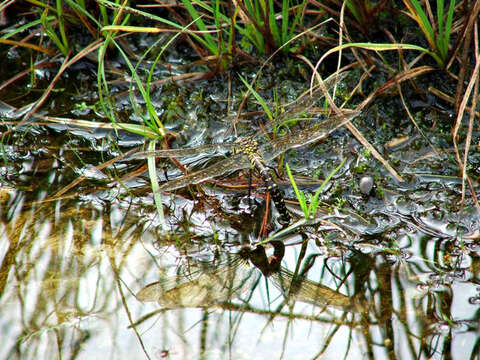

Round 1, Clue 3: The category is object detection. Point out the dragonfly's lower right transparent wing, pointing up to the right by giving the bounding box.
[262,111,360,161]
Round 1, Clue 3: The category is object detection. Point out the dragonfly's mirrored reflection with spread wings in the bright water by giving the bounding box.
[137,242,351,309]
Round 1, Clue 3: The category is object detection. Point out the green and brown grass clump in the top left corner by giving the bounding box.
[0,0,117,126]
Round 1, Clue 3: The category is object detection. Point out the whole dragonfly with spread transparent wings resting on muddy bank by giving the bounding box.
[131,72,359,223]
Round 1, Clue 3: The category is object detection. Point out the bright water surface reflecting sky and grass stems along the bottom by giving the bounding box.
[0,191,480,359]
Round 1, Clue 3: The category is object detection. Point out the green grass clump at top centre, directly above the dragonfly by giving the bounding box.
[99,0,307,72]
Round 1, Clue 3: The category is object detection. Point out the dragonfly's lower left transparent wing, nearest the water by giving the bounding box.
[159,154,250,192]
